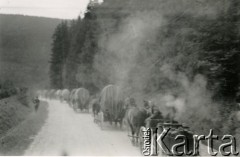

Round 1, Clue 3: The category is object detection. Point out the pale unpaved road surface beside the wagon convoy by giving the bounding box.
[25,101,141,156]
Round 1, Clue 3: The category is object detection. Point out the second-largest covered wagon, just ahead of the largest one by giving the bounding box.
[74,88,90,111]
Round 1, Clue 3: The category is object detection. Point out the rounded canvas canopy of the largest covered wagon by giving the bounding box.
[100,85,124,117]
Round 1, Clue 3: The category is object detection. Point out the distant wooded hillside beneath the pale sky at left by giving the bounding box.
[0,14,61,88]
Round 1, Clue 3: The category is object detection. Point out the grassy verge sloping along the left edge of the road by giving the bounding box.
[0,101,48,156]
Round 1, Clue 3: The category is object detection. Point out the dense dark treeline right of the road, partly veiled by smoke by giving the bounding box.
[50,0,240,133]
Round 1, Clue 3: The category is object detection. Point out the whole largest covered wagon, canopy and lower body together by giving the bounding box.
[100,85,125,124]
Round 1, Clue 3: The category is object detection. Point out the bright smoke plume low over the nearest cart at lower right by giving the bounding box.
[152,65,221,133]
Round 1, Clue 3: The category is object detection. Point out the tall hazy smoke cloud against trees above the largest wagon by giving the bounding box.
[95,12,164,92]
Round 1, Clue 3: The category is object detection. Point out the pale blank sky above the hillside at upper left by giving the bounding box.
[0,0,94,19]
